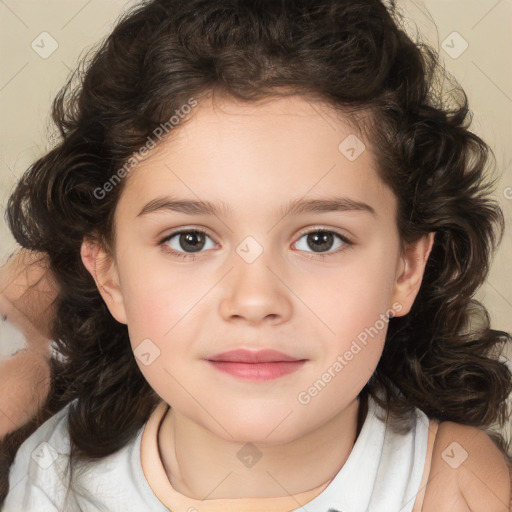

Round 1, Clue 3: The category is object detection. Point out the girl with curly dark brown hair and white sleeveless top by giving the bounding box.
[2,0,511,512]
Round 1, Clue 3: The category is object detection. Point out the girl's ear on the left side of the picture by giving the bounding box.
[80,238,127,324]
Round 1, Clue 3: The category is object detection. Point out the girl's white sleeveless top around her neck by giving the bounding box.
[2,397,429,512]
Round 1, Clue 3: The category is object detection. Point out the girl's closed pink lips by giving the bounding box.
[207,349,306,381]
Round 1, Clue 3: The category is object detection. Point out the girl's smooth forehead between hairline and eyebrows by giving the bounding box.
[119,96,394,220]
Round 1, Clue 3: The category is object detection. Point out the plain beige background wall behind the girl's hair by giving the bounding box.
[0,0,512,444]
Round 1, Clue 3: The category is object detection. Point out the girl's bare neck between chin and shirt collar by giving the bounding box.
[158,400,367,500]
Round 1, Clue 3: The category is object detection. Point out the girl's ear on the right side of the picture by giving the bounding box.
[392,232,435,316]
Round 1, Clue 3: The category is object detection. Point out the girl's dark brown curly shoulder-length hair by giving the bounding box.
[0,0,512,500]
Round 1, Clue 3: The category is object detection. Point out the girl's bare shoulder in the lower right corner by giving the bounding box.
[424,421,511,512]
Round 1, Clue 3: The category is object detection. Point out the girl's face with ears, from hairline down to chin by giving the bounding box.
[83,97,429,444]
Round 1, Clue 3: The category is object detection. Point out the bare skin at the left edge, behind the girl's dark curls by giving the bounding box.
[0,249,57,438]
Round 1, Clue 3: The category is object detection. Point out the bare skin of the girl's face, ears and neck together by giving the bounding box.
[82,96,433,499]
